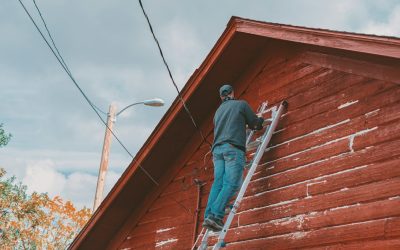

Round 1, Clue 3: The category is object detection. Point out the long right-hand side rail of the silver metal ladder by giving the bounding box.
[213,101,287,250]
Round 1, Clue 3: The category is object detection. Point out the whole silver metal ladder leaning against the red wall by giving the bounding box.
[192,101,288,250]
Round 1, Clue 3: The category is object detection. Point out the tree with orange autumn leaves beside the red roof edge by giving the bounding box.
[0,168,91,249]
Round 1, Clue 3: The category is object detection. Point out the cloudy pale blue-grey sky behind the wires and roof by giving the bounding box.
[0,0,400,208]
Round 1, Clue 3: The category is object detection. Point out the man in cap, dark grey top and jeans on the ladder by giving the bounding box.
[203,85,264,232]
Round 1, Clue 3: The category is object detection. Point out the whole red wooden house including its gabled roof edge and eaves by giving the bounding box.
[71,17,400,249]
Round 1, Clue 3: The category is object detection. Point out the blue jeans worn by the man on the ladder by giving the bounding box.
[204,143,245,219]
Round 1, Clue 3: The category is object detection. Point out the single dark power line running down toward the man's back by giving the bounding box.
[139,0,212,147]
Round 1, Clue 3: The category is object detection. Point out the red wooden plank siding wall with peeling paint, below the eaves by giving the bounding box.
[120,44,400,249]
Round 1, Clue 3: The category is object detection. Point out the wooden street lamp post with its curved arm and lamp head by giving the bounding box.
[93,98,164,212]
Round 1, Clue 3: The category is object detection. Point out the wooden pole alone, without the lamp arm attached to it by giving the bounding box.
[93,103,116,212]
